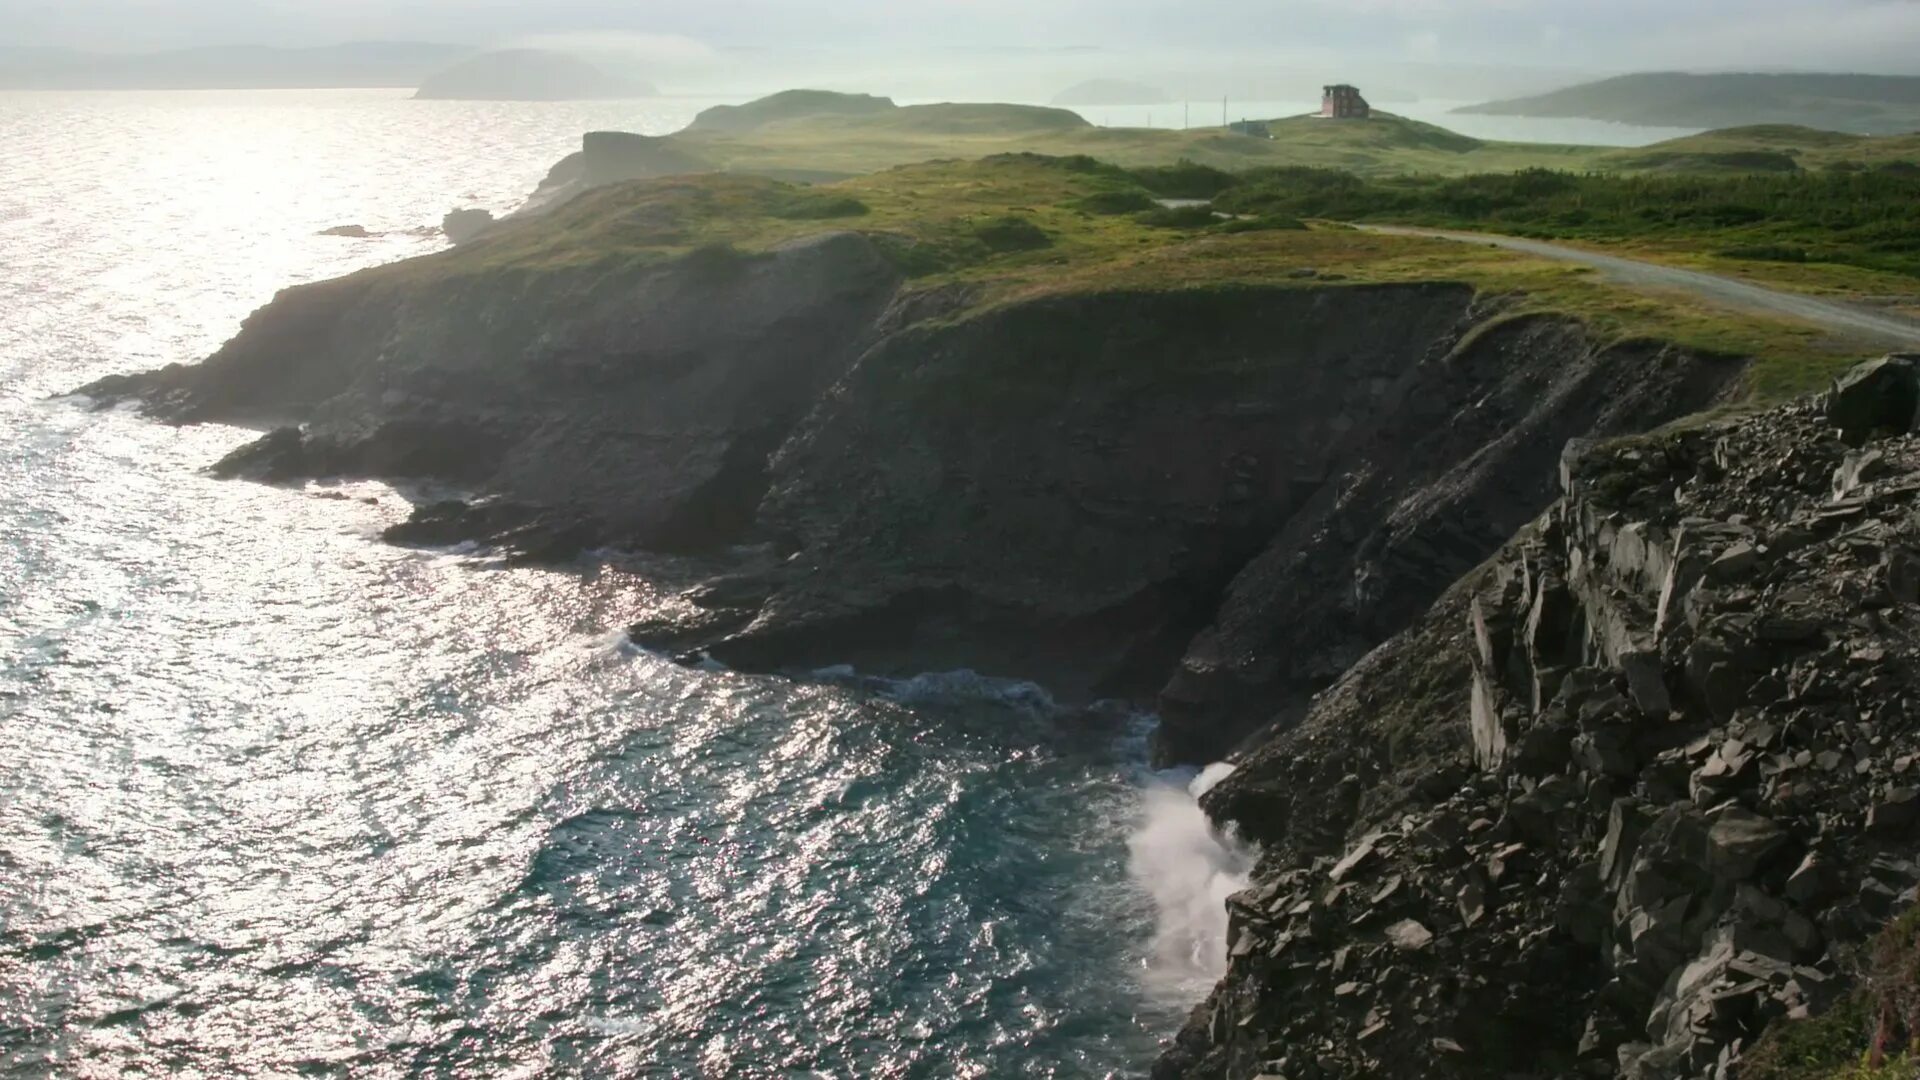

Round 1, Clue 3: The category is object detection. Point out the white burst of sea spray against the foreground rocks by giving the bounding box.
[1127,765,1254,986]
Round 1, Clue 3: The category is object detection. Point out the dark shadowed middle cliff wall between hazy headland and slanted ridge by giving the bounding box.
[668,286,1473,700]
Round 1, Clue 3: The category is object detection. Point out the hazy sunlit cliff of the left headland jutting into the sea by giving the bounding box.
[86,234,899,550]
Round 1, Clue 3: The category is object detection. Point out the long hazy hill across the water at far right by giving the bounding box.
[1455,73,1920,135]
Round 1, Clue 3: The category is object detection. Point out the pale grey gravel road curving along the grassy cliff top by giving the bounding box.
[1359,225,1920,348]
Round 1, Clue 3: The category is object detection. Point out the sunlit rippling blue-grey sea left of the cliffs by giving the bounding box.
[0,90,1248,1078]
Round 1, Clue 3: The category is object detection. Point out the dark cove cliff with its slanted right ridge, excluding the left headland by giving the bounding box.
[636,284,1738,703]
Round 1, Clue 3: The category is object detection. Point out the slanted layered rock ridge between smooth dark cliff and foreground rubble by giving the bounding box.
[1162,319,1738,761]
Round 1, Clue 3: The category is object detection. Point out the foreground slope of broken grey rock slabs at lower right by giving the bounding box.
[1158,359,1920,1078]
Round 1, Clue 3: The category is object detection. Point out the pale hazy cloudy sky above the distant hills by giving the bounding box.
[11,0,1920,73]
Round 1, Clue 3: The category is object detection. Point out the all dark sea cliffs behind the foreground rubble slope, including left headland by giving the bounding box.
[92,249,1738,714]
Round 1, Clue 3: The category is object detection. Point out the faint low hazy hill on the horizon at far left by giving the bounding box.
[0,42,472,90]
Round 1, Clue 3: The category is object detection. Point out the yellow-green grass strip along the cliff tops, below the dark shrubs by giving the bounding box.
[416,156,1876,400]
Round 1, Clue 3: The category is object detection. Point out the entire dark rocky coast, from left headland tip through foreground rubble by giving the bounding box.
[84,203,1920,1080]
